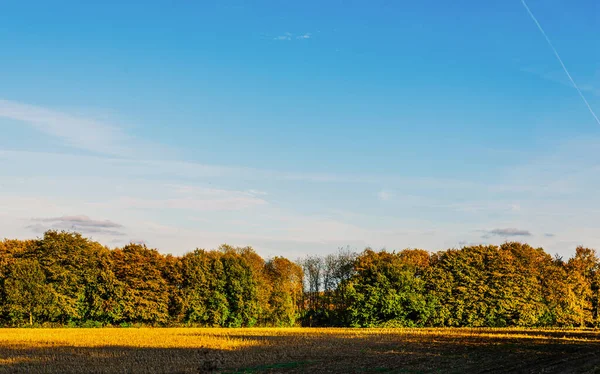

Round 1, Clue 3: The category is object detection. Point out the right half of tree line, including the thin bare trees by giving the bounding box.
[303,242,600,327]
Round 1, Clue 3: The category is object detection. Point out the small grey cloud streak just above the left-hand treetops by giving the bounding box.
[27,215,125,236]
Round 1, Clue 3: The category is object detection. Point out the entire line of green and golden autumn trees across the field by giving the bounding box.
[0,231,600,327]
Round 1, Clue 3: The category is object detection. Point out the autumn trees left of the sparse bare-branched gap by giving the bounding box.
[0,231,302,327]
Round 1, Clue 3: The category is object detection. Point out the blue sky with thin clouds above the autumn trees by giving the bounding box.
[0,0,600,259]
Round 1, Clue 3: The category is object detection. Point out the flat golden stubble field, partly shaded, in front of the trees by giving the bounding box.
[0,328,600,373]
